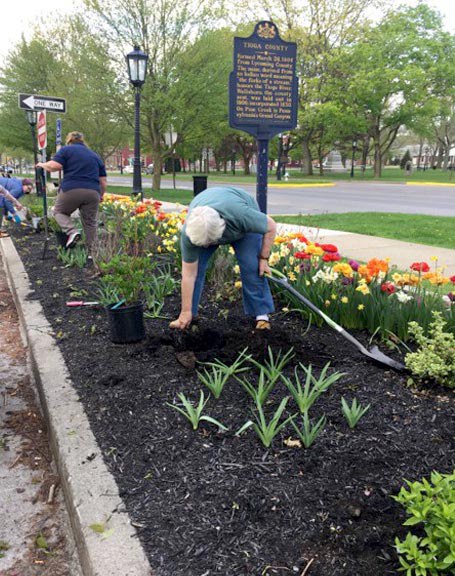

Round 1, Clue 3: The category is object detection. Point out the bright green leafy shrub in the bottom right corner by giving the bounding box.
[393,472,455,576]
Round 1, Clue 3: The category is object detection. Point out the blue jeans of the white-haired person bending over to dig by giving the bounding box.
[192,233,275,316]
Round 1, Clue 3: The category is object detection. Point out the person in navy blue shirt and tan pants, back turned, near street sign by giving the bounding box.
[36,132,107,252]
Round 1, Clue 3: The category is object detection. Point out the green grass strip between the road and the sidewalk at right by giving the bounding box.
[274,212,455,249]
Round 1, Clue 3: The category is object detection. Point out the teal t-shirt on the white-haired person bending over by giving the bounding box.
[180,186,267,262]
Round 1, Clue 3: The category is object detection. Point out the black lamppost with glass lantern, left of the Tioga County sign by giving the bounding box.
[126,46,148,200]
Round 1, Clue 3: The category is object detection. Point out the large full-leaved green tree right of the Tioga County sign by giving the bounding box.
[346,4,448,177]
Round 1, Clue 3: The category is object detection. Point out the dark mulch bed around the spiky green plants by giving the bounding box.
[9,230,455,576]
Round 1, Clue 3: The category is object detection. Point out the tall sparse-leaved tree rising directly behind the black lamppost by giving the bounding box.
[84,0,224,190]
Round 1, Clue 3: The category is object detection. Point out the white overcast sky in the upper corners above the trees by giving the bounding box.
[0,0,455,62]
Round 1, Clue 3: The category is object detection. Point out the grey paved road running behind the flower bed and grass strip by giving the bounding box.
[109,176,455,216]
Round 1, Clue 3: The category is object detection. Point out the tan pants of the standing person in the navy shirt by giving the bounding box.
[54,188,100,250]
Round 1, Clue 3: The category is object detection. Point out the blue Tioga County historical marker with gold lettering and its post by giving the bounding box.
[229,21,298,213]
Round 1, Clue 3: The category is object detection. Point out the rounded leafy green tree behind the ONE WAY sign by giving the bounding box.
[0,17,125,157]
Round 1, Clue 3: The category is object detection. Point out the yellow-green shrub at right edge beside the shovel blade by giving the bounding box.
[405,312,455,388]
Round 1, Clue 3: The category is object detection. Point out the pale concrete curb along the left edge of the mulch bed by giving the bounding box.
[0,238,152,576]
